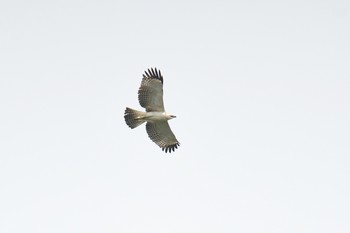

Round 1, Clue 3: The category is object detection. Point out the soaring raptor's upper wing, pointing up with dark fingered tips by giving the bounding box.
[138,68,165,112]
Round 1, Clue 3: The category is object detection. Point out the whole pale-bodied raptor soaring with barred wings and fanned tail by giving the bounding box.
[124,68,180,153]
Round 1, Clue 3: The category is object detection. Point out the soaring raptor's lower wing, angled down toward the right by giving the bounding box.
[146,121,180,153]
